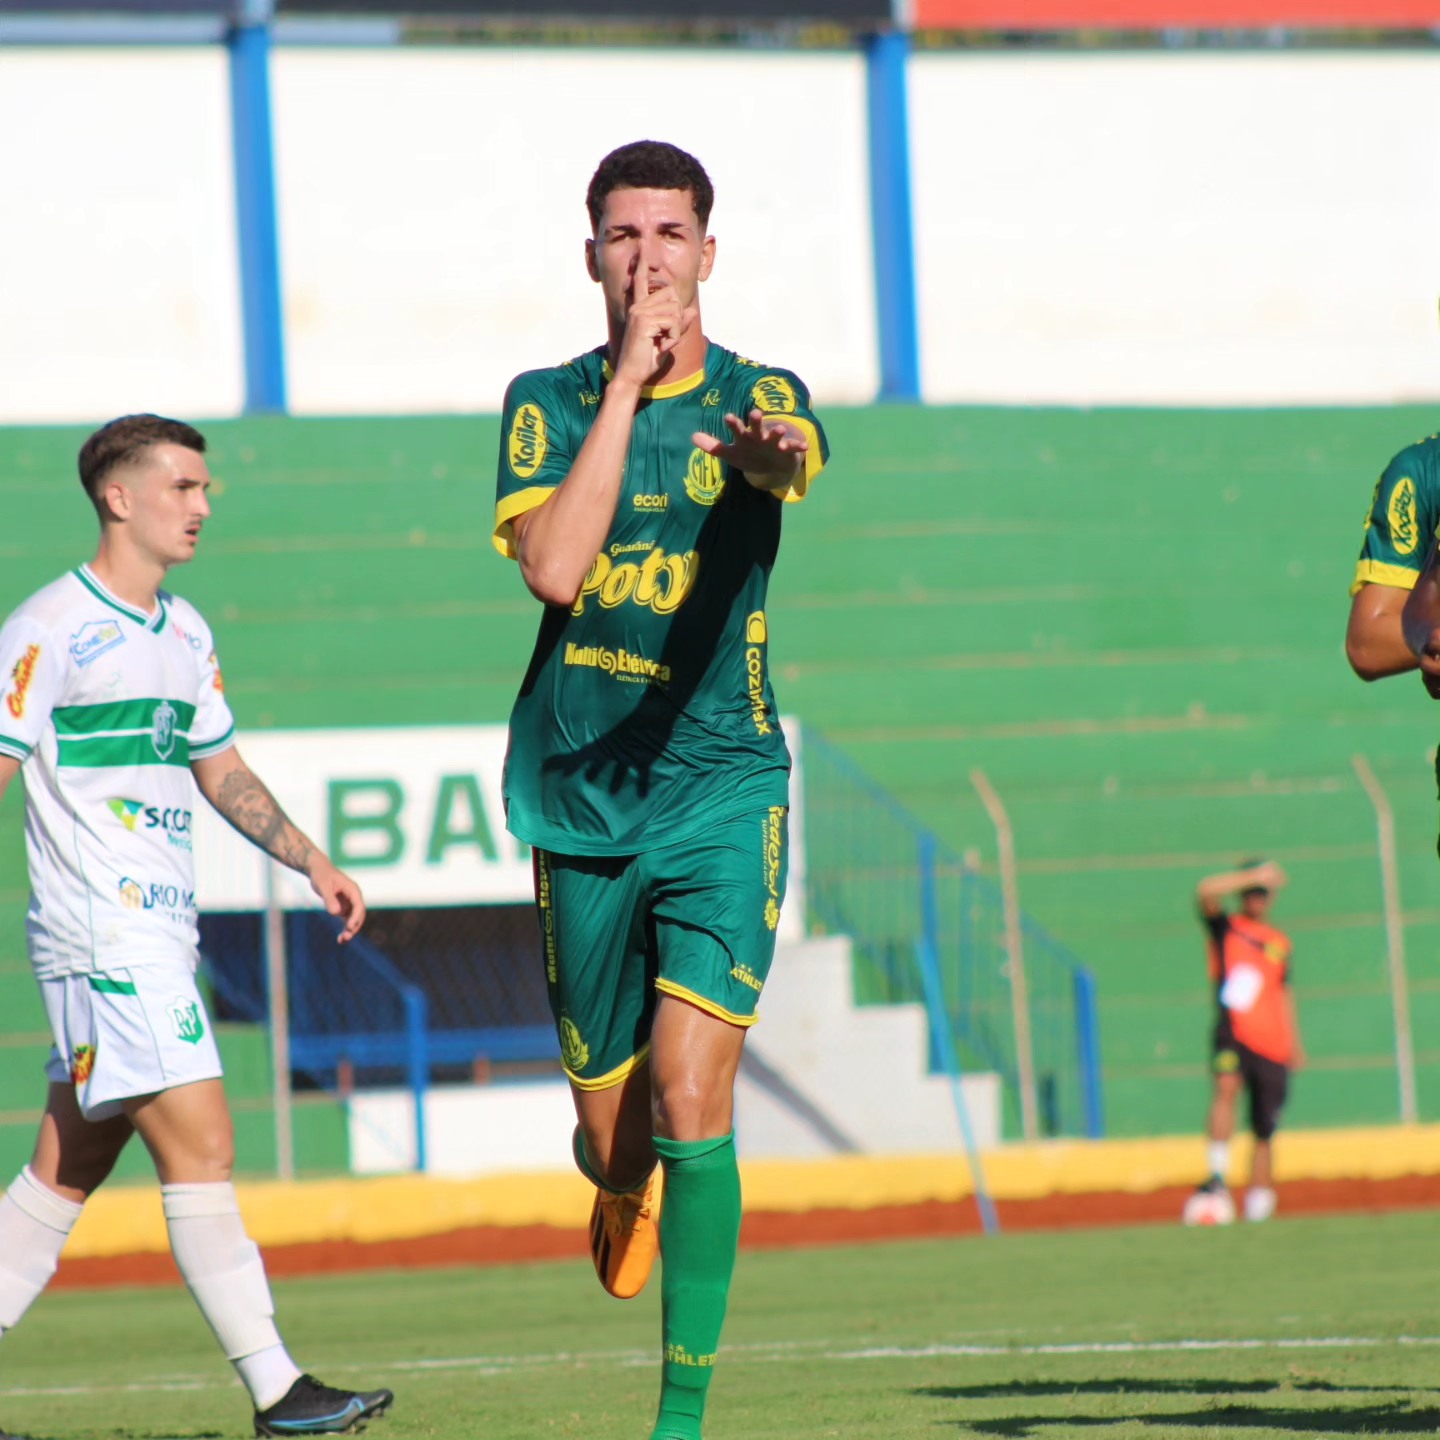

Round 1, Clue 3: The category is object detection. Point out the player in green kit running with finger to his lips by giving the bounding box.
[495,141,827,1440]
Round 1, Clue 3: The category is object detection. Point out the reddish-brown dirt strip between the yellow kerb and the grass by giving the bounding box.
[45,1175,1440,1287]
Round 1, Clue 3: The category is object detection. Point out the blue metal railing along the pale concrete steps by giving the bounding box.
[802,729,1104,1136]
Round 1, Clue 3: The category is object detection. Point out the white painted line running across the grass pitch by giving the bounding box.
[0,1335,1440,1400]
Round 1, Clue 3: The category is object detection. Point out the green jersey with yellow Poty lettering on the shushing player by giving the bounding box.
[494,344,828,855]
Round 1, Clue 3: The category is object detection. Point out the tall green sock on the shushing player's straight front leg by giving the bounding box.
[651,1133,740,1440]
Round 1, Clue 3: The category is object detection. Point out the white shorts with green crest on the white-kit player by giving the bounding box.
[40,960,220,1120]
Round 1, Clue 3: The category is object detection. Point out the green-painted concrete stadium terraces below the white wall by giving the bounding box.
[0,406,1440,1135]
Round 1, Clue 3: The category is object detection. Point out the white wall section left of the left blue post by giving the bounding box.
[0,46,243,422]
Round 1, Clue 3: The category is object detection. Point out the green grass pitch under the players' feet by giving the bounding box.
[0,1214,1440,1440]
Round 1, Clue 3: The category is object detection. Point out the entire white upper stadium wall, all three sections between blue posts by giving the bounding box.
[0,48,1440,423]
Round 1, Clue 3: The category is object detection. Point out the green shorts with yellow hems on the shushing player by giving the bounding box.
[534,805,789,1090]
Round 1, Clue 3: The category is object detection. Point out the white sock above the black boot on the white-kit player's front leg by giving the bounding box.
[160,1182,300,1410]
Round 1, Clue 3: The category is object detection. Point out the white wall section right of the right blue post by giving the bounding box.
[910,52,1440,405]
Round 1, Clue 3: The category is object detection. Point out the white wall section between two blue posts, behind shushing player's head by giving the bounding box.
[274,49,878,413]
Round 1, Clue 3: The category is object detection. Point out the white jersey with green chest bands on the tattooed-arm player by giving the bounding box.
[0,566,235,979]
